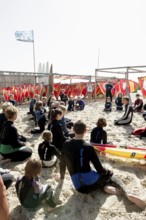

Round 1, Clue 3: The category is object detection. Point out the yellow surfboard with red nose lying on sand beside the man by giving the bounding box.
[94,146,146,159]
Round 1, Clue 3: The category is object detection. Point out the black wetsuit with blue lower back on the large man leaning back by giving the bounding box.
[62,139,112,193]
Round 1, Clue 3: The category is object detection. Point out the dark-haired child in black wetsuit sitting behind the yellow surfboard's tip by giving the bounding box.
[90,118,107,144]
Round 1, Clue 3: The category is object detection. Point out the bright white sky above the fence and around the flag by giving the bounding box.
[0,0,146,81]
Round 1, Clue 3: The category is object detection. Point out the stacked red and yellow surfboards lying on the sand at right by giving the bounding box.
[91,143,146,159]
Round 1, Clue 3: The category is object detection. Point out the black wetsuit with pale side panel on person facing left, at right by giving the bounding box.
[114,104,133,125]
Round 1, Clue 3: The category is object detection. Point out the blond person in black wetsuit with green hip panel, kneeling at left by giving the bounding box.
[0,106,32,161]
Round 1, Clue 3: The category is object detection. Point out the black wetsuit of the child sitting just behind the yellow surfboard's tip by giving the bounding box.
[90,127,107,144]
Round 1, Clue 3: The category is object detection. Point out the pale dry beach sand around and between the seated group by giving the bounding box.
[3,93,146,220]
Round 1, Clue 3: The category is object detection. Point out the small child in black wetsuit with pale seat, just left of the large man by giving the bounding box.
[38,130,60,167]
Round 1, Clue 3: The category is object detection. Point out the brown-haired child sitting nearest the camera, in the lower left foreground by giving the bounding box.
[15,159,55,209]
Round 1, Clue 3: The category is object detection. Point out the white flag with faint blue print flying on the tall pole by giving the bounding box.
[15,31,34,42]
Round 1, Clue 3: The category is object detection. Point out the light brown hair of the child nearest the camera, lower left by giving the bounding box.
[25,158,42,179]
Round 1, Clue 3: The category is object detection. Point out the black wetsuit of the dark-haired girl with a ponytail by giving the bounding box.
[48,120,66,151]
